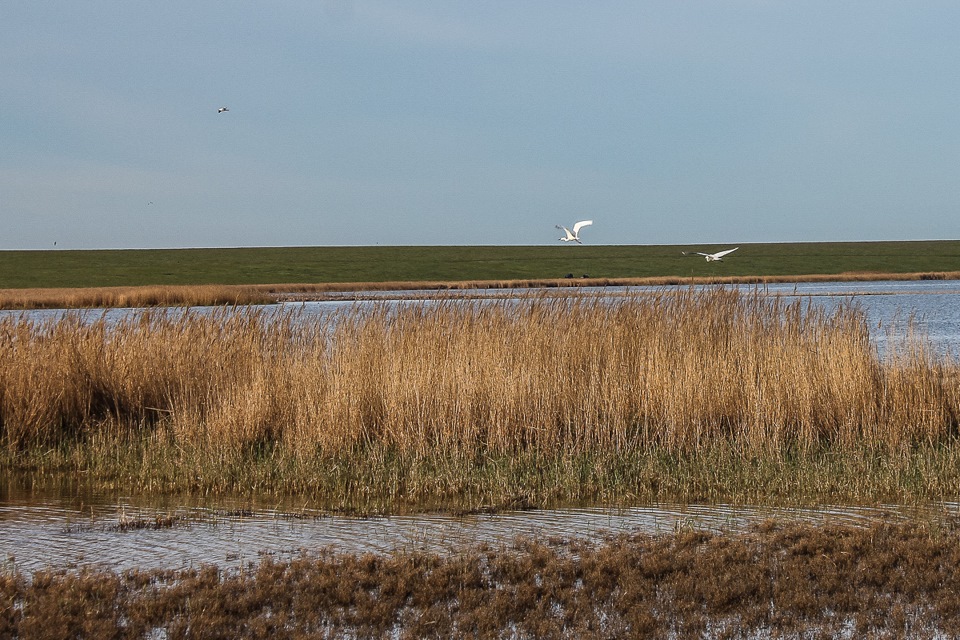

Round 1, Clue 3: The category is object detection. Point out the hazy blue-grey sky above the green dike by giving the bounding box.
[0,0,960,250]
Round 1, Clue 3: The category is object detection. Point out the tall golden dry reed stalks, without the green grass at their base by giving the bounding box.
[0,289,960,457]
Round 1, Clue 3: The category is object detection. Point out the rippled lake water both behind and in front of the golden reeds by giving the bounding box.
[0,281,960,573]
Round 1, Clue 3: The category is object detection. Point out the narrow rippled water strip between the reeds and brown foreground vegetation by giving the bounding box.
[0,488,960,574]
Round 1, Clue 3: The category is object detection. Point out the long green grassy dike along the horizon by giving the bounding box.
[0,240,960,289]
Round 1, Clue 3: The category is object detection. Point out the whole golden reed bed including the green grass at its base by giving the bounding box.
[0,289,960,510]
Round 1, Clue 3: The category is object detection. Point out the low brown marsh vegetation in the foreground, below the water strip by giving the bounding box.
[0,523,960,639]
